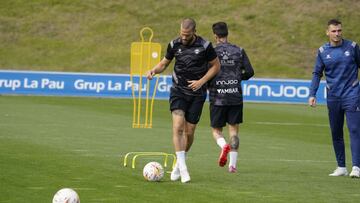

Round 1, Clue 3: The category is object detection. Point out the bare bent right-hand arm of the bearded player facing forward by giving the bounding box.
[188,57,220,91]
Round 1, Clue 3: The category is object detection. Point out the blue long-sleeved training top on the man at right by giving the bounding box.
[310,39,360,100]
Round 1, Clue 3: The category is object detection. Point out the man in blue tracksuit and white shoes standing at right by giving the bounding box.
[309,19,360,178]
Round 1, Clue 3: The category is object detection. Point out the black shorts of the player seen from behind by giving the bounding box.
[210,104,243,128]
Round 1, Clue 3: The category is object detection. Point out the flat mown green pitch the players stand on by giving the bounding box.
[0,96,360,203]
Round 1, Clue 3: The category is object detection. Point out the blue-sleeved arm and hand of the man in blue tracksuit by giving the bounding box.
[308,51,325,107]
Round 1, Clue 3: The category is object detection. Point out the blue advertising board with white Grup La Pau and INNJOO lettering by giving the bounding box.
[0,70,326,104]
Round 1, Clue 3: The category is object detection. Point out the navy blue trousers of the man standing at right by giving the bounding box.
[327,96,360,167]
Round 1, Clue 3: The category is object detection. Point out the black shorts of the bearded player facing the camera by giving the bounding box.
[169,88,206,124]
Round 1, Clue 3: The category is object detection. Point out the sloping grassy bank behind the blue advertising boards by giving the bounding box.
[0,0,360,79]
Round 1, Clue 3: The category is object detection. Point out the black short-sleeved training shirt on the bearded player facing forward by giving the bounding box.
[165,36,217,96]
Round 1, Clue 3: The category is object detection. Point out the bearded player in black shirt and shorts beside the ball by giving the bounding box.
[147,18,220,183]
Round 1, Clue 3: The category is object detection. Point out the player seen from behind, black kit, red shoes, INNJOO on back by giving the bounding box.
[209,22,254,173]
